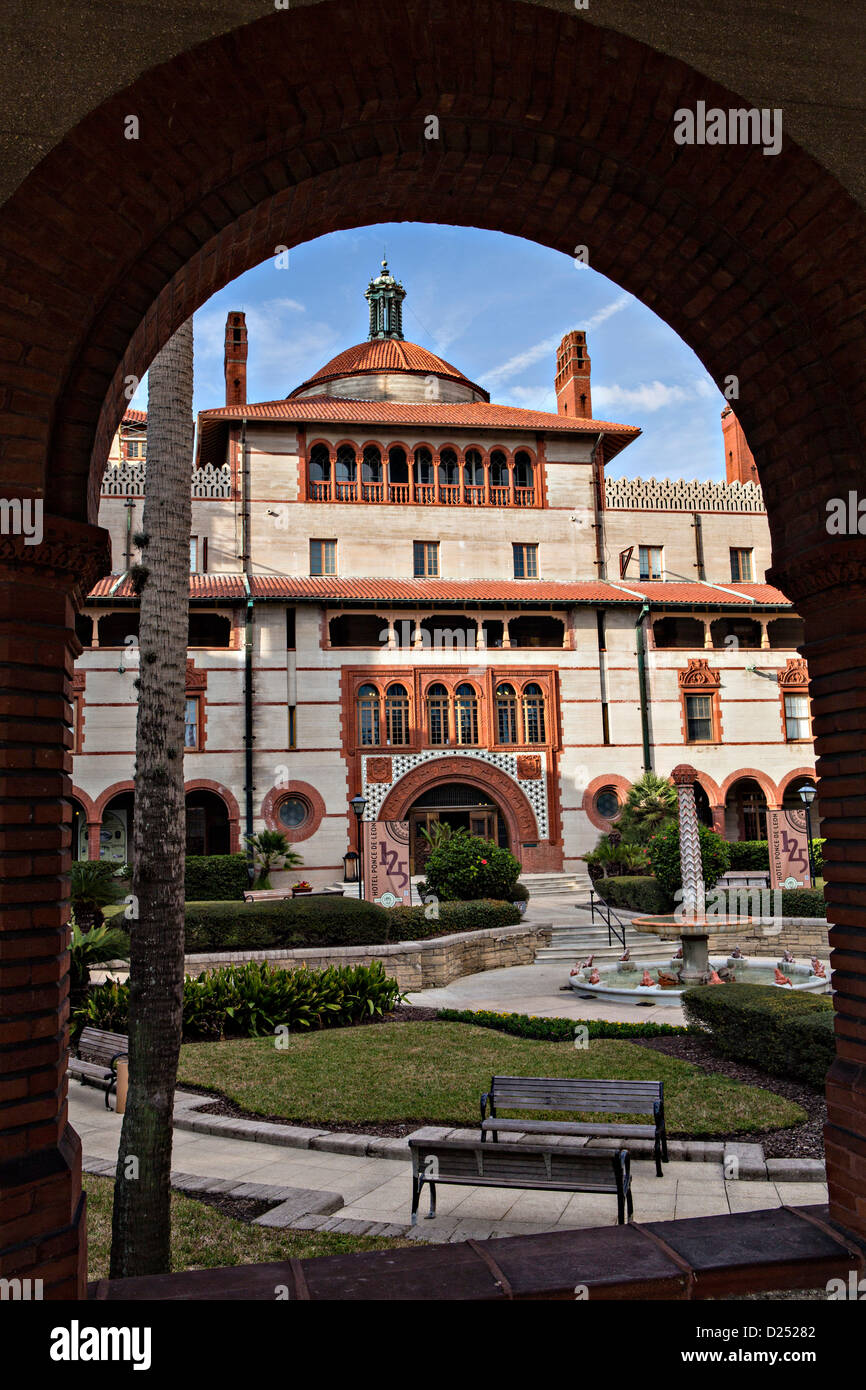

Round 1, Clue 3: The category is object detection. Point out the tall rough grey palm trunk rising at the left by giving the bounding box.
[111,320,193,1279]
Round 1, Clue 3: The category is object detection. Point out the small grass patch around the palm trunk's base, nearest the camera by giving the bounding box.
[83,1170,409,1279]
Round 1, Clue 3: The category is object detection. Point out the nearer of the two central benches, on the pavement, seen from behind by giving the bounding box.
[409,1138,634,1226]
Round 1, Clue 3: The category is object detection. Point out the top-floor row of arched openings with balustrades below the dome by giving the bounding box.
[307,443,538,507]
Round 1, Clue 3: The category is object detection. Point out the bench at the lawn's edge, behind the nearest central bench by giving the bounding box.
[481,1076,667,1177]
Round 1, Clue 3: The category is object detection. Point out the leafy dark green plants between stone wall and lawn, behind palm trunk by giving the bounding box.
[75,960,402,1041]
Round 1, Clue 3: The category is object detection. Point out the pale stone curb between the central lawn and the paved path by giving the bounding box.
[174,1091,827,1183]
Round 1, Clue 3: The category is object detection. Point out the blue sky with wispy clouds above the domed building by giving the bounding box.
[132,222,726,478]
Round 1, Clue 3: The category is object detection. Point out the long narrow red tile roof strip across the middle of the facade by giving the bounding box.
[89,574,791,609]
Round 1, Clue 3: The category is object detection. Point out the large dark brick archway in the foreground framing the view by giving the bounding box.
[0,0,866,1297]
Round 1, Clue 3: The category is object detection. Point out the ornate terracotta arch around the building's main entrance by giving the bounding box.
[377,758,562,873]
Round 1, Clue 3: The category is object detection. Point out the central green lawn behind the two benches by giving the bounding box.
[178,1022,806,1136]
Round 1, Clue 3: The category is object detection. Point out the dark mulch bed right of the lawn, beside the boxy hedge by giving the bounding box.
[628,1034,827,1159]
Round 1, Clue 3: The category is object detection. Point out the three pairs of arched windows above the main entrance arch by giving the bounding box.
[356,681,546,748]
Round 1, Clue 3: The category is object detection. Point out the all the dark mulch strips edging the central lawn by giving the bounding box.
[182,1005,827,1159]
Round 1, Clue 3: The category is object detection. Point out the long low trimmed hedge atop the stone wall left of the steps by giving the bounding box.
[186,894,523,954]
